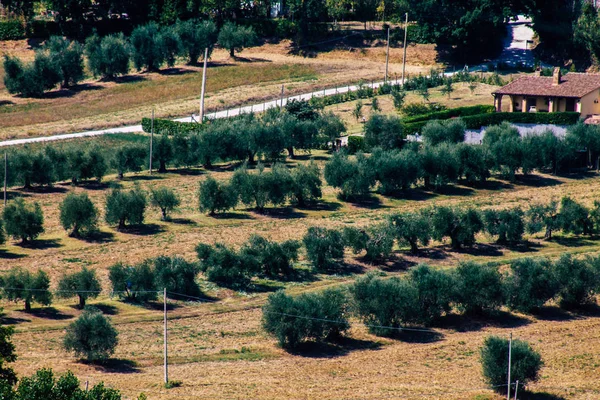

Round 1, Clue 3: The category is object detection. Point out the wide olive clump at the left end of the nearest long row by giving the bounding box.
[262,289,350,349]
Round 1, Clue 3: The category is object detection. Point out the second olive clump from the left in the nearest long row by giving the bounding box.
[350,274,418,336]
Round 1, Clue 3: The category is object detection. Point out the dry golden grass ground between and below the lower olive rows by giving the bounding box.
[0,145,600,400]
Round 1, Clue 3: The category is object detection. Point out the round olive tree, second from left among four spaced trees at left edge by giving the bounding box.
[59,193,98,237]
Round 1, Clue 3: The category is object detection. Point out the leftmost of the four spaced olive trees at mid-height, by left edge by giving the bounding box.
[2,197,44,244]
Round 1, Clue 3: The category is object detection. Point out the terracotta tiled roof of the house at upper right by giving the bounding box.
[494,72,600,98]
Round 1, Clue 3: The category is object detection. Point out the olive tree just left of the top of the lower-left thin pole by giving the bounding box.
[108,260,157,302]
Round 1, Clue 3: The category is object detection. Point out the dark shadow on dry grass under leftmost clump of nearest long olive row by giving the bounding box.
[289,336,381,358]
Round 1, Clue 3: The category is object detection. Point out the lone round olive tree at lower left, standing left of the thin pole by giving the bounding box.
[63,308,118,361]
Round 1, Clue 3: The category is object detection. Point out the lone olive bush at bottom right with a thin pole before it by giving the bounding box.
[481,336,543,393]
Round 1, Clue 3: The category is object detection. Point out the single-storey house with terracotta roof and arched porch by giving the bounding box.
[492,68,600,117]
